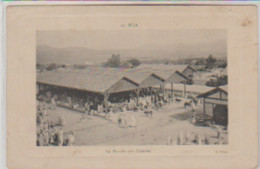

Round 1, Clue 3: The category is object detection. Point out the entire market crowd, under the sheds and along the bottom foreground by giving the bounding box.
[37,84,211,146]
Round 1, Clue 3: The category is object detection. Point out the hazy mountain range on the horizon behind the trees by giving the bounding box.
[36,45,226,65]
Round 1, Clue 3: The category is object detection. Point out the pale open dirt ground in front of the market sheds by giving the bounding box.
[38,103,228,146]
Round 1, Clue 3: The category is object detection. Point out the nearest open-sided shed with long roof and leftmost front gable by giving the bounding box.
[37,69,138,111]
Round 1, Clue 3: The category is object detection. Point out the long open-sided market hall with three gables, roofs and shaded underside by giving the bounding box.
[37,67,193,112]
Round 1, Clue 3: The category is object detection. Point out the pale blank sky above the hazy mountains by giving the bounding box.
[36,29,227,64]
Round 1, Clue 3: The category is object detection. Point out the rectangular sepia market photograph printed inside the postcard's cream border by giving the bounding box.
[36,29,229,146]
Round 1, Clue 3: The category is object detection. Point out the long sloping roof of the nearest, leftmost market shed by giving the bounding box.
[37,68,137,93]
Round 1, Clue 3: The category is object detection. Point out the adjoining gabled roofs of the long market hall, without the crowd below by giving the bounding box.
[37,67,193,93]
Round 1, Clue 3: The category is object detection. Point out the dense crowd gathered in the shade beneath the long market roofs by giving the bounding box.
[37,85,185,114]
